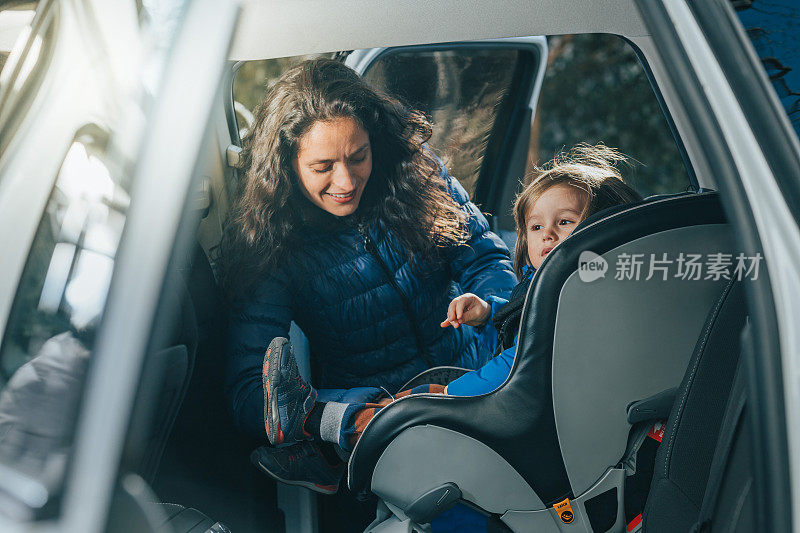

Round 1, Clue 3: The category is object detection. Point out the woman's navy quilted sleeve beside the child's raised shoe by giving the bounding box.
[225,268,292,440]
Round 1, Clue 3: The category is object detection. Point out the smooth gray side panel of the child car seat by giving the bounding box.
[552,224,733,495]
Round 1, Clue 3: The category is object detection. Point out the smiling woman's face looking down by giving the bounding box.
[293,118,372,217]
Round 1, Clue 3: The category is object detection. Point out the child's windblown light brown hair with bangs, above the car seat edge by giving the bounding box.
[514,143,642,279]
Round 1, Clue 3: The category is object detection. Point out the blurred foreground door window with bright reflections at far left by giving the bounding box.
[0,127,129,512]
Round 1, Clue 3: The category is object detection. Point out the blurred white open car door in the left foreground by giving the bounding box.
[0,0,237,531]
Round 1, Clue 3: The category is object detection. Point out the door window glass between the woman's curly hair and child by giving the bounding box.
[364,48,521,196]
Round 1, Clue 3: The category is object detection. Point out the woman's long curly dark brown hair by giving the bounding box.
[215,58,468,300]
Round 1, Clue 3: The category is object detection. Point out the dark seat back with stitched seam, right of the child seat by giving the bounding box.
[643,276,746,532]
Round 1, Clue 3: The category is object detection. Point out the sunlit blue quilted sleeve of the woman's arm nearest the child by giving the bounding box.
[442,167,517,300]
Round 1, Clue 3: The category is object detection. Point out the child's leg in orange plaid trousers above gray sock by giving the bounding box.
[305,385,444,451]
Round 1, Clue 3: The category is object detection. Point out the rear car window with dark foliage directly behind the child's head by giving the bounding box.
[528,34,690,196]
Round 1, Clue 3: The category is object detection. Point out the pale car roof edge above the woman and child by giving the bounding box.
[230,0,647,60]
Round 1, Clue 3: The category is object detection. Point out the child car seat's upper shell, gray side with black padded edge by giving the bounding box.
[348,193,733,528]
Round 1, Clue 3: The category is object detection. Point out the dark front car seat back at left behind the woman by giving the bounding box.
[153,245,282,531]
